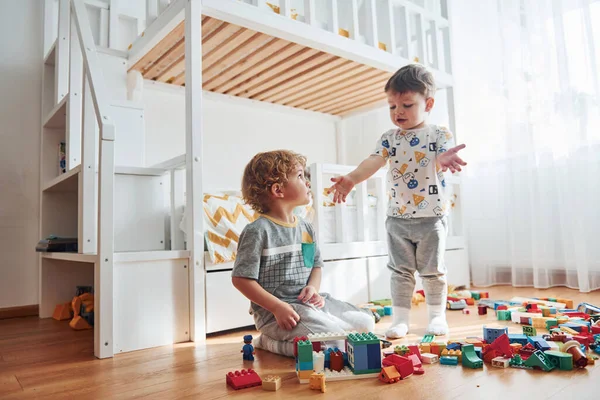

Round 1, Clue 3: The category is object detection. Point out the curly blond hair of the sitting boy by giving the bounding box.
[242,150,306,213]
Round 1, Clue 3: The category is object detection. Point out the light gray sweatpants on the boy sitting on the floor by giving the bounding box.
[255,293,375,356]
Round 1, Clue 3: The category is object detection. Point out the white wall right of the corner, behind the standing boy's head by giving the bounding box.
[339,89,450,165]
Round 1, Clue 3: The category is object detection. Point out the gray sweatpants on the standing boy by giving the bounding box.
[385,217,448,308]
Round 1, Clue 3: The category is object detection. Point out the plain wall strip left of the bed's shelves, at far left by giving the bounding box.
[0,0,43,308]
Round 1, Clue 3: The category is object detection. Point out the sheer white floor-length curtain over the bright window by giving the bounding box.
[450,0,600,292]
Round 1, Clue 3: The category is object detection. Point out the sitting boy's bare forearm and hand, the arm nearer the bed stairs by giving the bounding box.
[231,276,300,331]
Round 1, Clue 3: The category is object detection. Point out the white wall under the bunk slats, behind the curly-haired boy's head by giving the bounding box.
[144,81,337,190]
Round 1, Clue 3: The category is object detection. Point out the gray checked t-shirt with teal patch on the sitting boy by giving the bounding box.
[231,216,323,324]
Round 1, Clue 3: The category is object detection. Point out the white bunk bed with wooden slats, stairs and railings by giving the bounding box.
[40,0,468,358]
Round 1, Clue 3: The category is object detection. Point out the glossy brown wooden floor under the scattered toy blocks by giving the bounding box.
[0,287,600,400]
